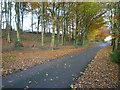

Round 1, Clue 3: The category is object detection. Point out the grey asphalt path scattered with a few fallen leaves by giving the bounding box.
[2,43,108,88]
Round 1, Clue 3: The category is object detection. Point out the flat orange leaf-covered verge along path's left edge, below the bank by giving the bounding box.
[2,45,95,76]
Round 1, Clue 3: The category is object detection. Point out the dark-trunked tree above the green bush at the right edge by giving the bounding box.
[111,2,120,51]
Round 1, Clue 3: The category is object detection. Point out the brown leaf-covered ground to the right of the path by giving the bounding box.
[71,46,120,88]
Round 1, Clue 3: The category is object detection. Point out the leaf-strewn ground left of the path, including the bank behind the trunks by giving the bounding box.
[0,30,98,76]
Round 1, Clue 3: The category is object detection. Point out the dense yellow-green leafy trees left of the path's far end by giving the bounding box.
[68,2,105,46]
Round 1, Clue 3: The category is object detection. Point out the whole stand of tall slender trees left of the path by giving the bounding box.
[1,2,111,50]
